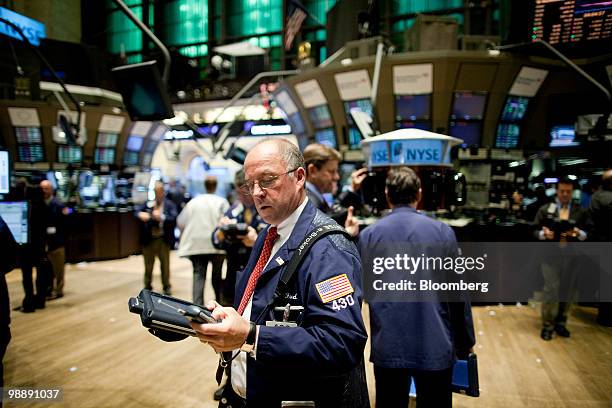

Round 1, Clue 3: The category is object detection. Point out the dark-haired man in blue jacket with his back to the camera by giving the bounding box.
[359,167,474,408]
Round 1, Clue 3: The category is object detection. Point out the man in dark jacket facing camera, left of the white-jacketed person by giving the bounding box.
[137,181,177,295]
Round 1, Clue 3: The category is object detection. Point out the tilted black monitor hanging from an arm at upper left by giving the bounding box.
[111,61,174,121]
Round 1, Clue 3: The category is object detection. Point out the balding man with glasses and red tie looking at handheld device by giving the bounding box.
[192,140,369,408]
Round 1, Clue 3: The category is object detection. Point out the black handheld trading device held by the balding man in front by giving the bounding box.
[128,289,218,336]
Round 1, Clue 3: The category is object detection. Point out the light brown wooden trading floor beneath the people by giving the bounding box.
[5,254,612,408]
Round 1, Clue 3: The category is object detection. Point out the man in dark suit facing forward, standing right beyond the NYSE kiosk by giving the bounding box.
[533,178,589,341]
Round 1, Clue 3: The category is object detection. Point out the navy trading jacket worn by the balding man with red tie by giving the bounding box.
[234,202,367,407]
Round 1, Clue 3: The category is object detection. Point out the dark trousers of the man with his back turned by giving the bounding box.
[374,365,453,408]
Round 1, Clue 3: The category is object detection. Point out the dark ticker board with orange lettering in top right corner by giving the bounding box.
[529,0,612,44]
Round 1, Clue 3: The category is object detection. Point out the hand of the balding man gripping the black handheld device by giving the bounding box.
[191,301,250,353]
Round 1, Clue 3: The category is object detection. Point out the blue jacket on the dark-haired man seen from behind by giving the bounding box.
[359,207,475,370]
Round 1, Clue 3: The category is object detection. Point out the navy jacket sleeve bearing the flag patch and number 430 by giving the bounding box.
[256,238,367,375]
